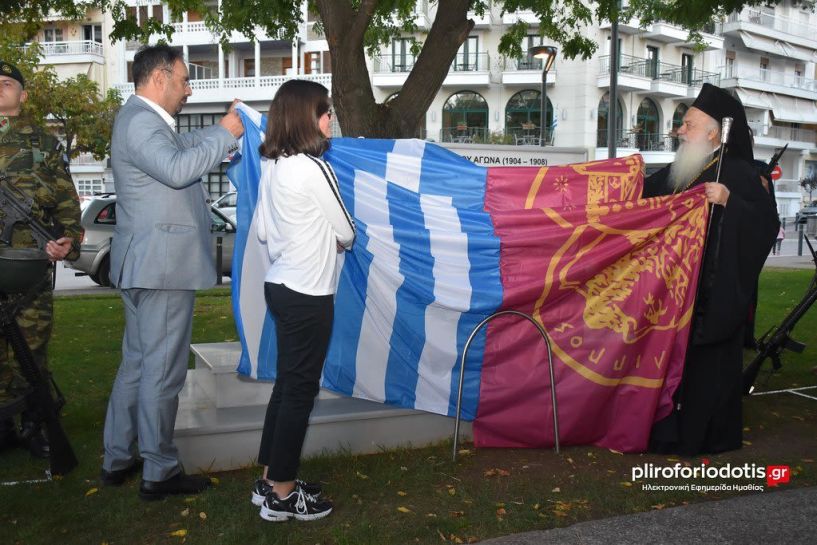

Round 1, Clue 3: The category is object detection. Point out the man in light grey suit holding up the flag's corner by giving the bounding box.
[101,45,244,500]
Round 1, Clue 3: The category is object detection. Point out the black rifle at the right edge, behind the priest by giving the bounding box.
[742,232,817,395]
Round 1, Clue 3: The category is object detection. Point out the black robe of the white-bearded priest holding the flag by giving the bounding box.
[642,155,780,456]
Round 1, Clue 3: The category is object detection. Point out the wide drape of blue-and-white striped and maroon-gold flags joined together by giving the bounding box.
[228,108,706,451]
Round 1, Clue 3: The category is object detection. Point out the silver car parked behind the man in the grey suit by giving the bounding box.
[65,194,235,286]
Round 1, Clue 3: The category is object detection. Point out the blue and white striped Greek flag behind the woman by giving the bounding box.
[228,105,502,419]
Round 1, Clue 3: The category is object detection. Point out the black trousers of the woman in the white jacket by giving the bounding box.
[258,282,335,482]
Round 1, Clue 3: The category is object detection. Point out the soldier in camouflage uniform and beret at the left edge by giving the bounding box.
[0,61,83,457]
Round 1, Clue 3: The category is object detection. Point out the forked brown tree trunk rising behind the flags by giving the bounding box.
[317,0,474,138]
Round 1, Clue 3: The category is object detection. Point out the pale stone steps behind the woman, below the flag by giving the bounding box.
[175,343,471,473]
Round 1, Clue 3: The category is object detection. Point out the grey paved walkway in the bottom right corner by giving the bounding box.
[481,485,817,545]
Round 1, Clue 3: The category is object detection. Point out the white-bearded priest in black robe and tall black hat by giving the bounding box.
[643,84,779,456]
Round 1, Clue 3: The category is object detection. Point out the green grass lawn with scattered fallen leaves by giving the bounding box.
[0,270,817,545]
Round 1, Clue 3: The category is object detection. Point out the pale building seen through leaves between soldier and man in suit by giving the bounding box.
[25,5,113,196]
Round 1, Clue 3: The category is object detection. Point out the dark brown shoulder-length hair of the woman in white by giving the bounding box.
[259,79,330,159]
